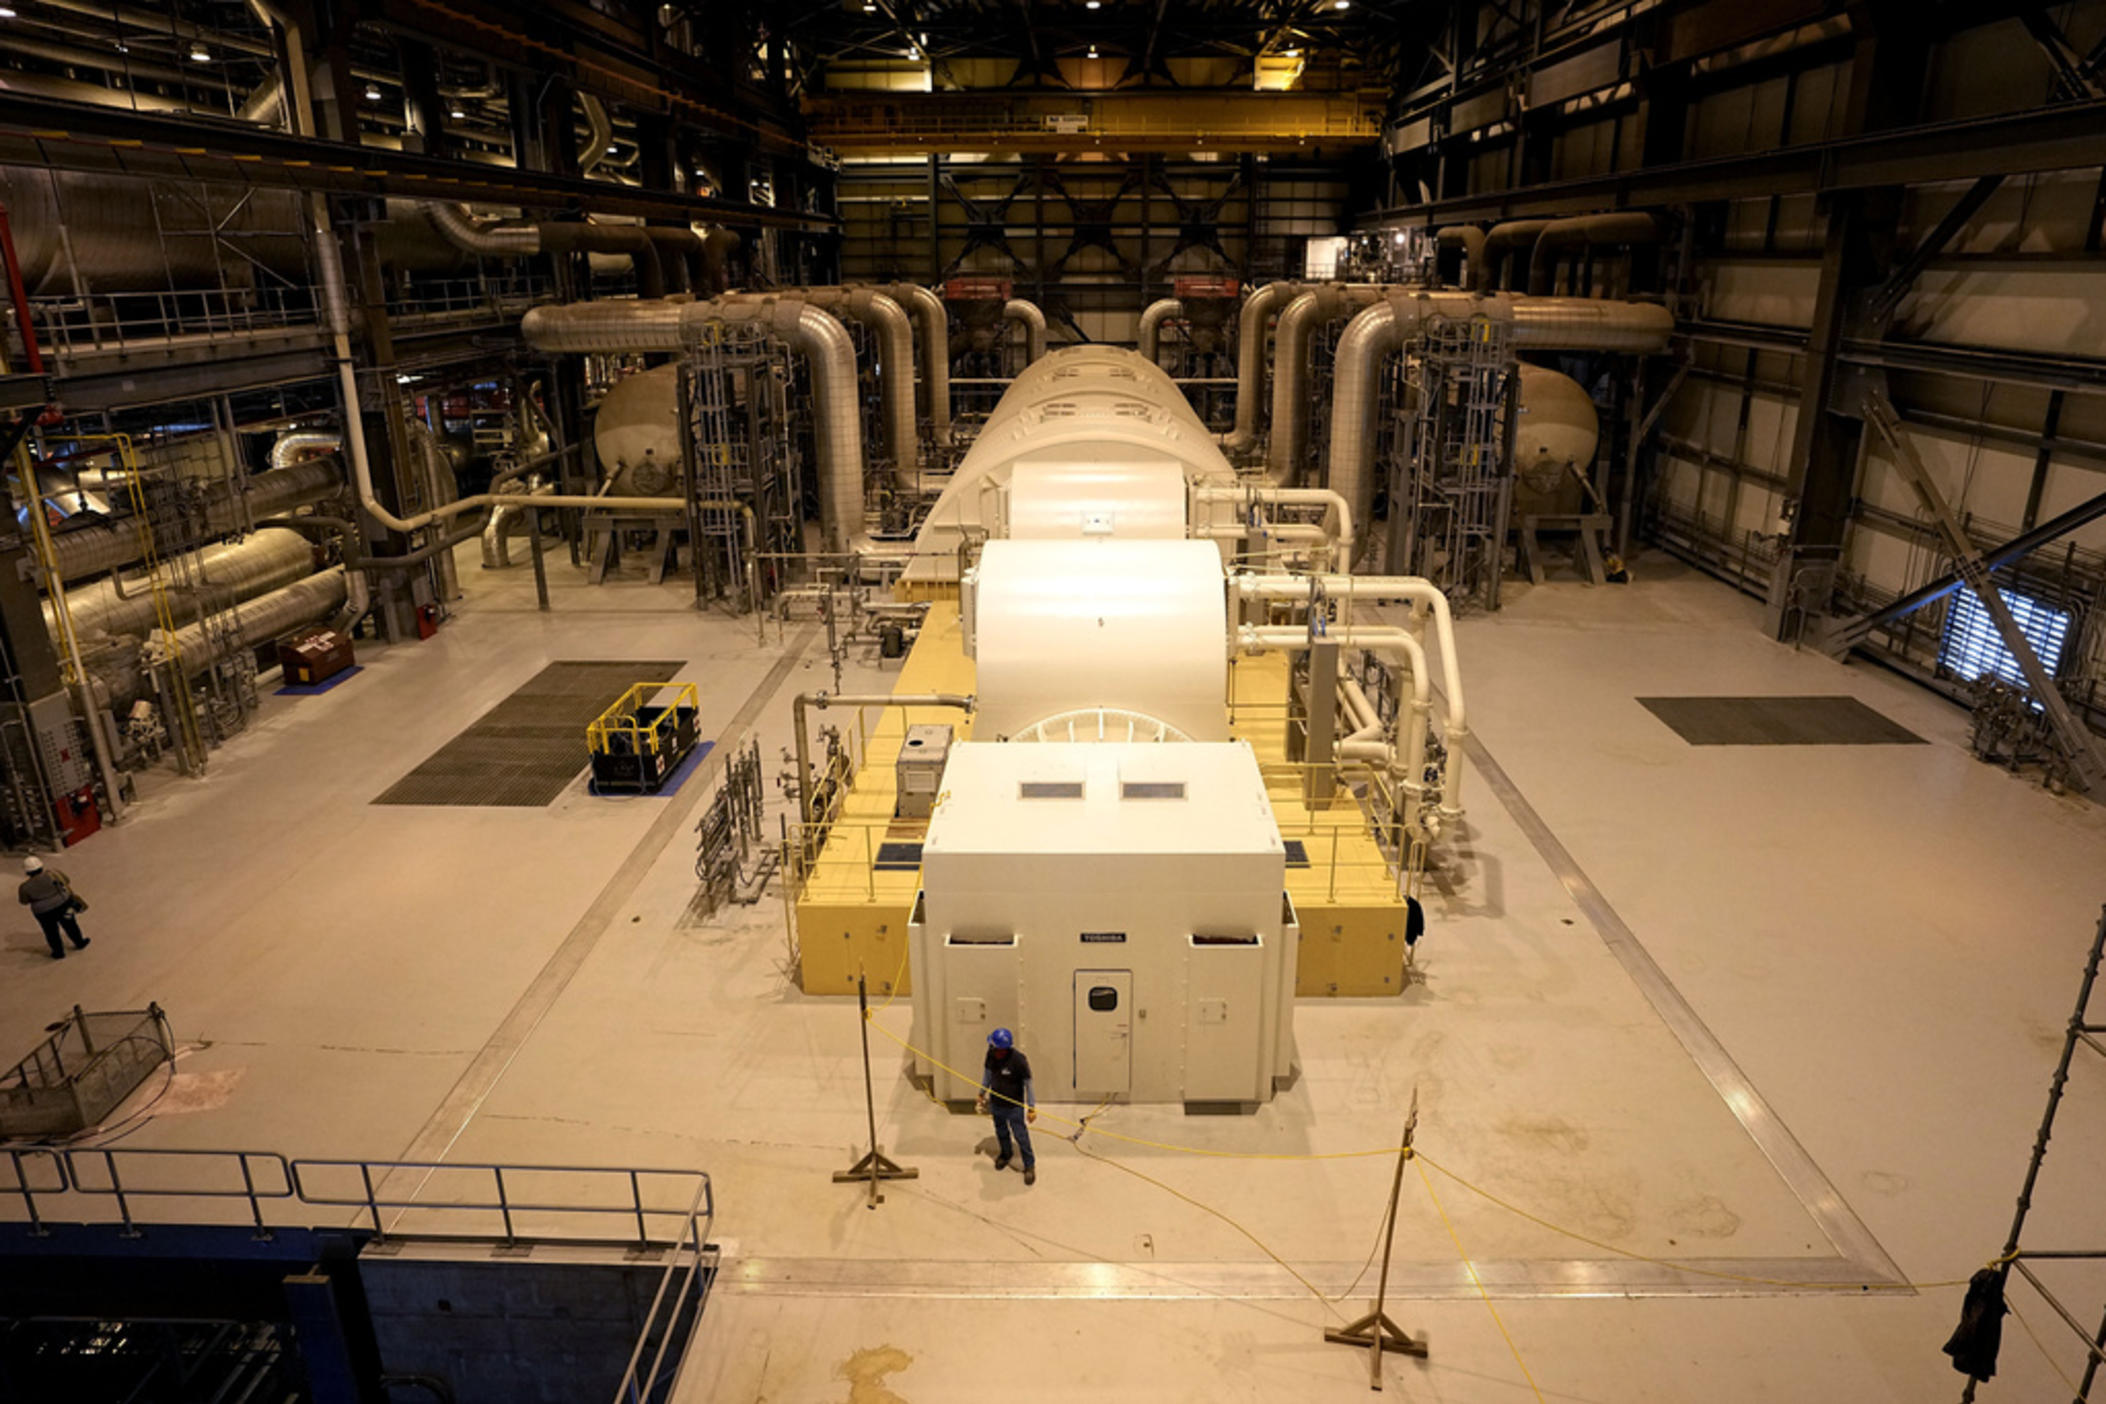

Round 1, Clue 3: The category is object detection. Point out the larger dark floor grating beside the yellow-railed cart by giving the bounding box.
[373,659,682,808]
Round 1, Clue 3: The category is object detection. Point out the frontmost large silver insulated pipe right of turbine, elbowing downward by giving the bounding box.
[1325,293,1674,547]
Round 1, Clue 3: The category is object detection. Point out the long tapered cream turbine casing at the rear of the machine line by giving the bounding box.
[903,345,1236,585]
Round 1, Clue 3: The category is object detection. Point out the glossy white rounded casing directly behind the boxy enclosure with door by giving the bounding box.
[971,539,1228,741]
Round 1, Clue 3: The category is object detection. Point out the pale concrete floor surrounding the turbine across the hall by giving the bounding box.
[0,554,2106,1404]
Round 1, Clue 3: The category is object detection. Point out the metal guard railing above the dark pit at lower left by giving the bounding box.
[0,1145,716,1255]
